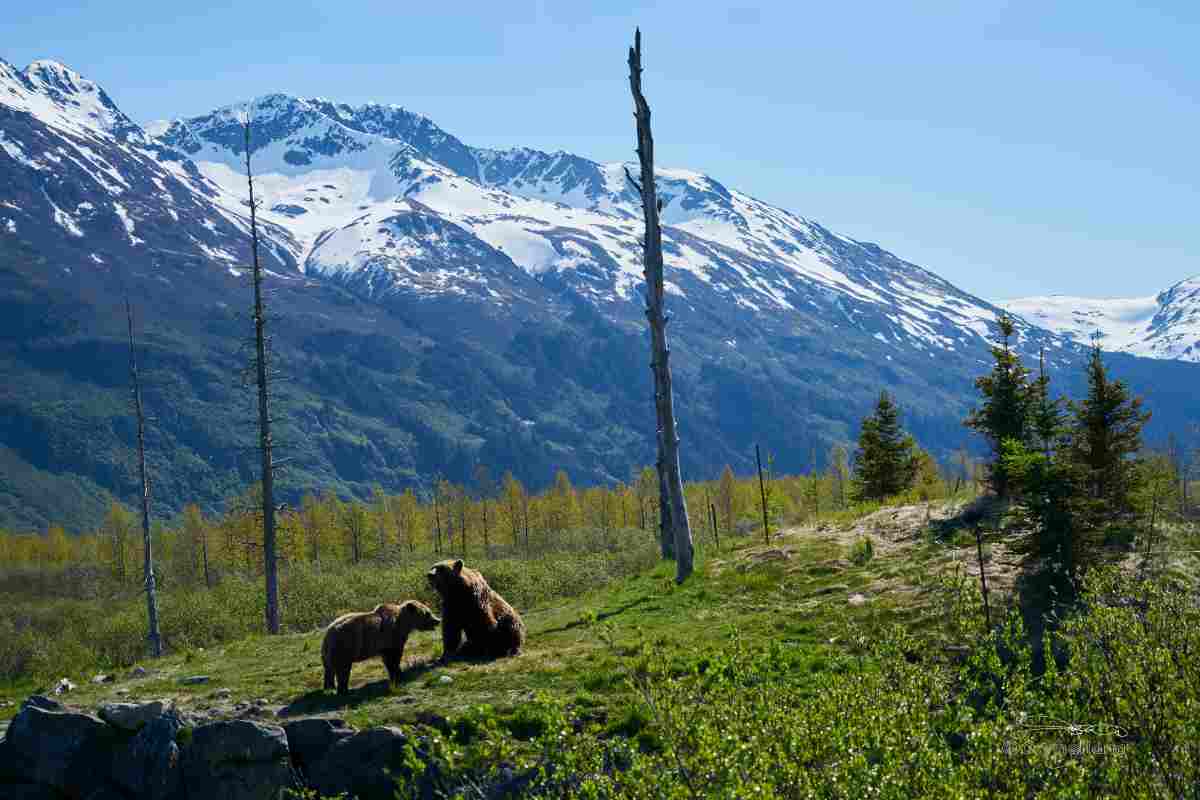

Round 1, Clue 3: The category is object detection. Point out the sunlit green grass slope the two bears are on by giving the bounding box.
[0,513,955,724]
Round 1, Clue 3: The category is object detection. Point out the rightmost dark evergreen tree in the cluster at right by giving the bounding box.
[1069,344,1150,518]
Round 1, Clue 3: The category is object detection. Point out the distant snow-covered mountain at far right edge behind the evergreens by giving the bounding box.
[1000,277,1200,361]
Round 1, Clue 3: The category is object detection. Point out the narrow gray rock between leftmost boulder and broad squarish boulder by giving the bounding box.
[113,703,188,800]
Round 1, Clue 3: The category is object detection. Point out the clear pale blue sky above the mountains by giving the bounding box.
[0,0,1200,300]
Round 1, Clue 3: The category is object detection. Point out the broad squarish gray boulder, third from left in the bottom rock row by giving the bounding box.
[182,720,300,800]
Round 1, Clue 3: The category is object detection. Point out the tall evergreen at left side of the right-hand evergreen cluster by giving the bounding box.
[966,312,1032,497]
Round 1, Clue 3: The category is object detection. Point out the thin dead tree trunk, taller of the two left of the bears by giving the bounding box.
[242,114,280,633]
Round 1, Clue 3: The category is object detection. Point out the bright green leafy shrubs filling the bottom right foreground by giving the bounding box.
[444,572,1200,800]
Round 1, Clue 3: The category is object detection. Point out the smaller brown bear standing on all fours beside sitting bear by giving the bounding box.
[320,600,442,694]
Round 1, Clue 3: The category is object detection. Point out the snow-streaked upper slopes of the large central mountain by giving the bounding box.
[158,89,1041,354]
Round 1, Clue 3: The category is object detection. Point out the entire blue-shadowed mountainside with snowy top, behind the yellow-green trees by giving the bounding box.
[0,57,1194,525]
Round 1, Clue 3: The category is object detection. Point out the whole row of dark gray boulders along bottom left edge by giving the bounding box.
[0,696,453,800]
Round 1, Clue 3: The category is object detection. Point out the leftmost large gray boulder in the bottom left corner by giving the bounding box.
[4,697,120,798]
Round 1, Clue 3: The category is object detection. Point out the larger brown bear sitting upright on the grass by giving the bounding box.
[427,559,524,661]
